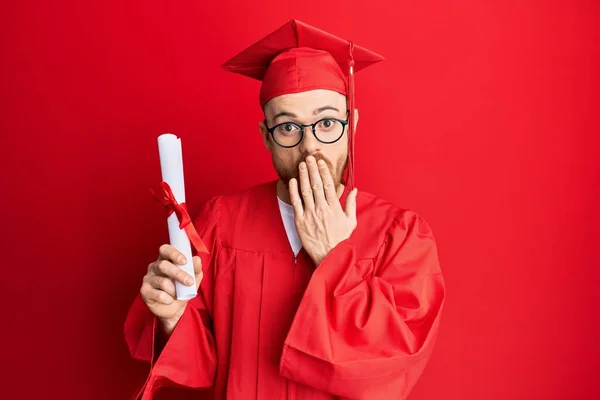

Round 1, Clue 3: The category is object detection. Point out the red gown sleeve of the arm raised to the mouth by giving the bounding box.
[280,211,445,399]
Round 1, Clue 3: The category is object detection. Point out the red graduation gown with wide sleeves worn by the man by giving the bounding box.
[125,182,445,400]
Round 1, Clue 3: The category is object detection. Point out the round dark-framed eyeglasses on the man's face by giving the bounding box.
[265,117,348,148]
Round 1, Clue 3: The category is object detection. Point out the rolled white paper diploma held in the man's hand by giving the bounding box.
[158,133,197,300]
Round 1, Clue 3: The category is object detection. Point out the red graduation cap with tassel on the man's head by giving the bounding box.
[223,19,384,188]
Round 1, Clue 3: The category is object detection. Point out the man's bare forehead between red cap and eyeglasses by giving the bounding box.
[265,89,346,117]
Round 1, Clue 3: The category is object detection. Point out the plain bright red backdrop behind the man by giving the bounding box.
[0,0,600,400]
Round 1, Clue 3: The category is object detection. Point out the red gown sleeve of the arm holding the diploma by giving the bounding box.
[124,197,220,400]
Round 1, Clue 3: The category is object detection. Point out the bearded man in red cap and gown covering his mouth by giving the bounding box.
[125,20,445,400]
